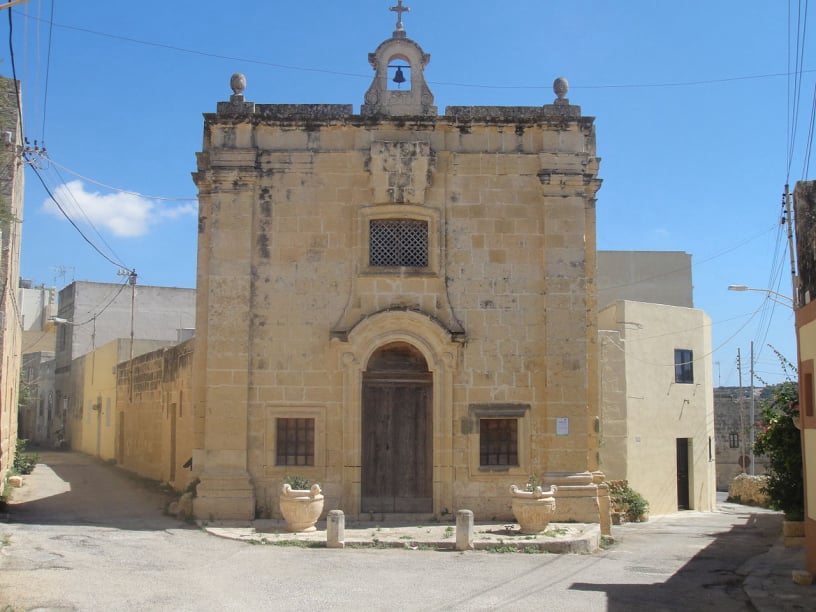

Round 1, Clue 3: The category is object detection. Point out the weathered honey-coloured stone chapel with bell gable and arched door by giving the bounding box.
[192,13,608,522]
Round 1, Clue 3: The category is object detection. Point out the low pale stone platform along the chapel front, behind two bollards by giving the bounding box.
[199,520,601,554]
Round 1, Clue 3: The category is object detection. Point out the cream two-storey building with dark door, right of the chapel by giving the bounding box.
[598,300,716,514]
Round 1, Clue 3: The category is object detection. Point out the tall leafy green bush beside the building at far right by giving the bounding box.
[754,380,805,521]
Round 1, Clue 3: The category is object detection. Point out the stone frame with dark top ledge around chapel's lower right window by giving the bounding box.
[463,403,532,479]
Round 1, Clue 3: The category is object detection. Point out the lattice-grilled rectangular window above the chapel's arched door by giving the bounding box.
[368,219,428,268]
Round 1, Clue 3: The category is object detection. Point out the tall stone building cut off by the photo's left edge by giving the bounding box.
[0,77,23,488]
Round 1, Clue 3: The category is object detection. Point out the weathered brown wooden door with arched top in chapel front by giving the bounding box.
[360,342,433,513]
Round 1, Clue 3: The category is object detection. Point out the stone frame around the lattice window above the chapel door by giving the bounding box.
[358,204,441,276]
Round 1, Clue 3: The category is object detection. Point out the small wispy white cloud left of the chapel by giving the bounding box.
[43,180,197,238]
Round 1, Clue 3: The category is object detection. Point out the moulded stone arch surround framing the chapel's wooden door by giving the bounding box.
[340,310,461,516]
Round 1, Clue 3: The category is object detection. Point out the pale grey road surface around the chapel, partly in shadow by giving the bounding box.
[0,452,816,612]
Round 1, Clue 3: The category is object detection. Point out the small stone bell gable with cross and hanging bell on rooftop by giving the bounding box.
[360,0,437,117]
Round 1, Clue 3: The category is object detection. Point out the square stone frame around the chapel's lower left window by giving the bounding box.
[264,404,327,479]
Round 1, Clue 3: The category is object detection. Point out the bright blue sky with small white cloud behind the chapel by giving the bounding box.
[0,0,816,385]
